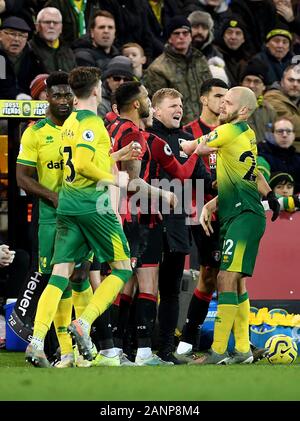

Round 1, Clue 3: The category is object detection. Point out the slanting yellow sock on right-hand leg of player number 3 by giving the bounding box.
[80,271,125,325]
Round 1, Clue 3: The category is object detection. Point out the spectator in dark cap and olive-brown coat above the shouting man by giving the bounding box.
[144,16,211,124]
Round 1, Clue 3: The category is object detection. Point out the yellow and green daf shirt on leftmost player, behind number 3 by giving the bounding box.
[17,118,63,223]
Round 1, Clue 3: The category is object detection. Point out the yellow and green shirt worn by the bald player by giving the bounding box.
[206,122,265,222]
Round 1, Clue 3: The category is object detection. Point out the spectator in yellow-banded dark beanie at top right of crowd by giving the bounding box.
[254,23,293,84]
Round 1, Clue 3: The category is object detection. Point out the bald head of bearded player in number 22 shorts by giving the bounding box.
[219,86,257,124]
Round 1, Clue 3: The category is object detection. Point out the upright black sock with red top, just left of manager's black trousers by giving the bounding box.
[136,293,156,348]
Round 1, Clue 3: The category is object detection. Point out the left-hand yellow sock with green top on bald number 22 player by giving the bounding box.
[211,292,238,354]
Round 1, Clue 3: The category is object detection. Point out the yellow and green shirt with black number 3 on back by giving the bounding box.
[57,110,112,215]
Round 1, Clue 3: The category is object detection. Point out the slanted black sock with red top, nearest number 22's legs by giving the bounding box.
[180,289,211,345]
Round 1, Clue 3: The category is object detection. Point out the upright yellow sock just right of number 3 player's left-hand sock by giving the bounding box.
[54,290,73,355]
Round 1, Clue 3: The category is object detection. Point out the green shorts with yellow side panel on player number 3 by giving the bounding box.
[51,212,130,264]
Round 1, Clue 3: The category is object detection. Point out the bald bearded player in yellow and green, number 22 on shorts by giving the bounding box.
[182,87,280,364]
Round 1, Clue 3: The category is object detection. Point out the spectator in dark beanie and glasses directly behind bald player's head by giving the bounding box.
[241,60,277,143]
